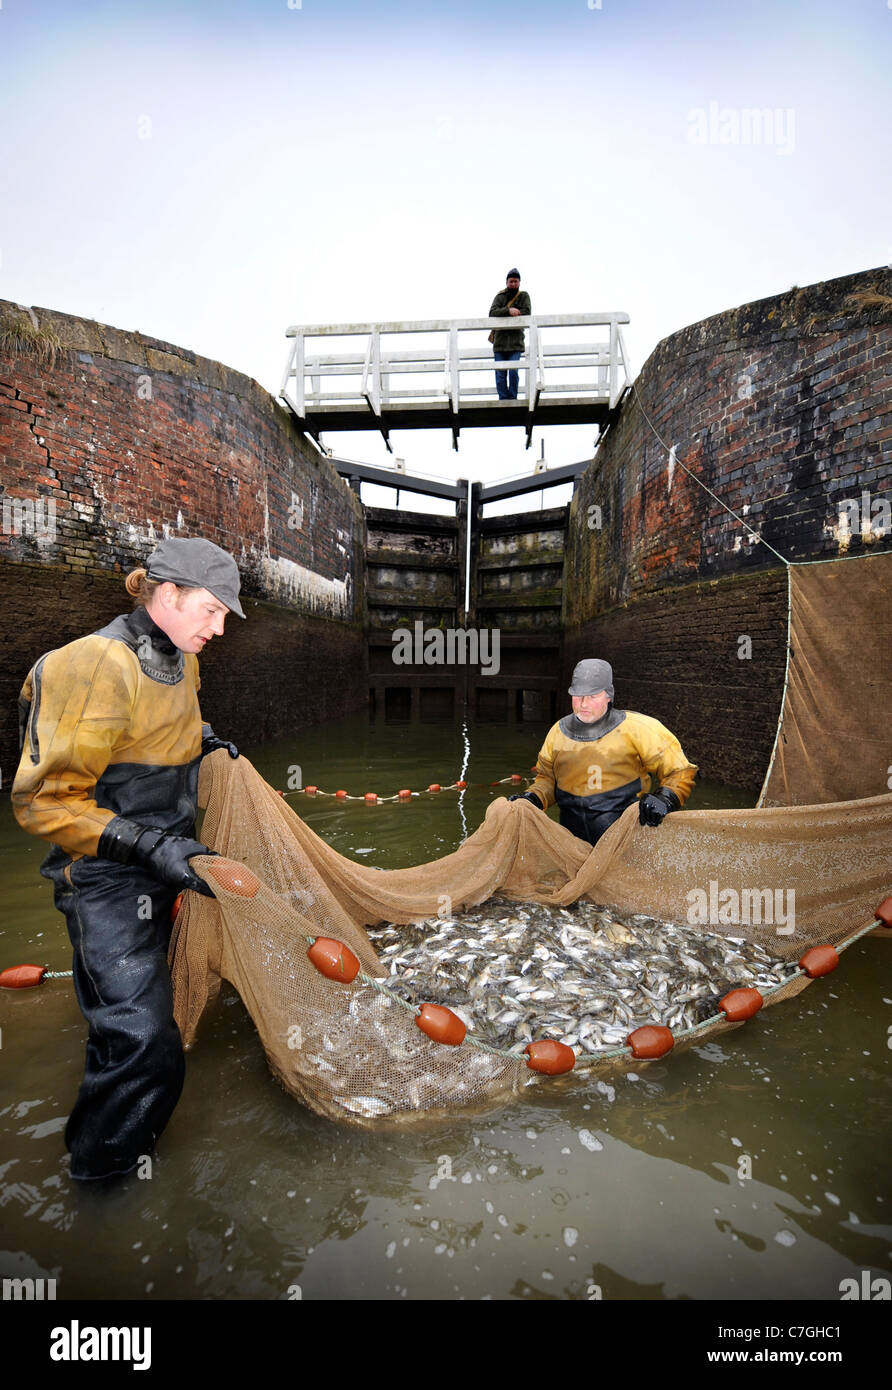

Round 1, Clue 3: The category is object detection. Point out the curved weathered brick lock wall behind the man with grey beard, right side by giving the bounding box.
[564,270,892,788]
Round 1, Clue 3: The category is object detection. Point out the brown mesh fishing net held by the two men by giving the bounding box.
[171,556,892,1125]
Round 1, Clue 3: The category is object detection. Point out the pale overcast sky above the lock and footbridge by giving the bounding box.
[0,0,892,517]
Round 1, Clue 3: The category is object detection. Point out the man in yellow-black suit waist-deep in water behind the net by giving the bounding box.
[509,659,697,845]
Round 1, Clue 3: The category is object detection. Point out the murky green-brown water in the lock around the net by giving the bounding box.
[0,719,892,1301]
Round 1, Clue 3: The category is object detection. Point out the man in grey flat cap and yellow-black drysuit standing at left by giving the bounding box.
[13,538,245,1180]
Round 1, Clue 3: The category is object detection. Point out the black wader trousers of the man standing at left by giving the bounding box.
[43,855,185,1179]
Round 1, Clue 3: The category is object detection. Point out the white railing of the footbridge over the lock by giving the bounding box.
[281,313,631,420]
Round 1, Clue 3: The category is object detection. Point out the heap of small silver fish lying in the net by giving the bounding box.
[368,898,796,1052]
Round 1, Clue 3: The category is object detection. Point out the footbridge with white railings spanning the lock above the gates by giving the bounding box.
[281,313,631,449]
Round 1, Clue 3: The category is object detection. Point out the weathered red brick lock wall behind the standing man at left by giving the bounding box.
[0,302,367,784]
